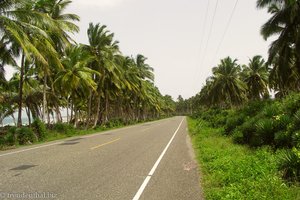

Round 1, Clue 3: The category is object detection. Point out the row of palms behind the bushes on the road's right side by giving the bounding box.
[186,0,300,107]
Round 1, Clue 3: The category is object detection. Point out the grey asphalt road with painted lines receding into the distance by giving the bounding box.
[0,117,201,200]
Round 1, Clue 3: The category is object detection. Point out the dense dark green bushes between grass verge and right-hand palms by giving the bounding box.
[219,94,300,148]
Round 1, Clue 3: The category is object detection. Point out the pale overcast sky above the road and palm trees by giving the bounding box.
[8,0,270,100]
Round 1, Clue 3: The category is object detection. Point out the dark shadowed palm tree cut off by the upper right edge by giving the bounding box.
[257,0,300,94]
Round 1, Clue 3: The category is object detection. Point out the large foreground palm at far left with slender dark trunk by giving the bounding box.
[0,0,65,126]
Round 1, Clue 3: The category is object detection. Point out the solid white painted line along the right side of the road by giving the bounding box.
[132,118,184,200]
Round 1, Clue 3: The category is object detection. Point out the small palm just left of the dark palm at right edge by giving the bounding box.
[242,55,269,99]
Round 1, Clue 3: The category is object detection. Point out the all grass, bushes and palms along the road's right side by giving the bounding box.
[177,0,300,199]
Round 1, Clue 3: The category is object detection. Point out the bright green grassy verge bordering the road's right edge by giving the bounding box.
[188,118,300,200]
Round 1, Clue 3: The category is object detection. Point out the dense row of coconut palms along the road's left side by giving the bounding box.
[0,0,174,127]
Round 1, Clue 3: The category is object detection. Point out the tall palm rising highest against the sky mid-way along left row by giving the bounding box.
[85,23,120,127]
